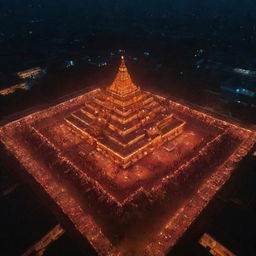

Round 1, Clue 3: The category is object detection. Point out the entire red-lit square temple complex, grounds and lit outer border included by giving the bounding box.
[0,57,256,256]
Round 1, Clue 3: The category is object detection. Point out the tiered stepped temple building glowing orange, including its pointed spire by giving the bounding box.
[65,57,185,168]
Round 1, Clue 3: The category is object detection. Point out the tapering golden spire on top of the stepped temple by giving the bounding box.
[107,56,139,96]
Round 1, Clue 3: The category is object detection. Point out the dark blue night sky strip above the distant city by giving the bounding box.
[0,0,256,33]
